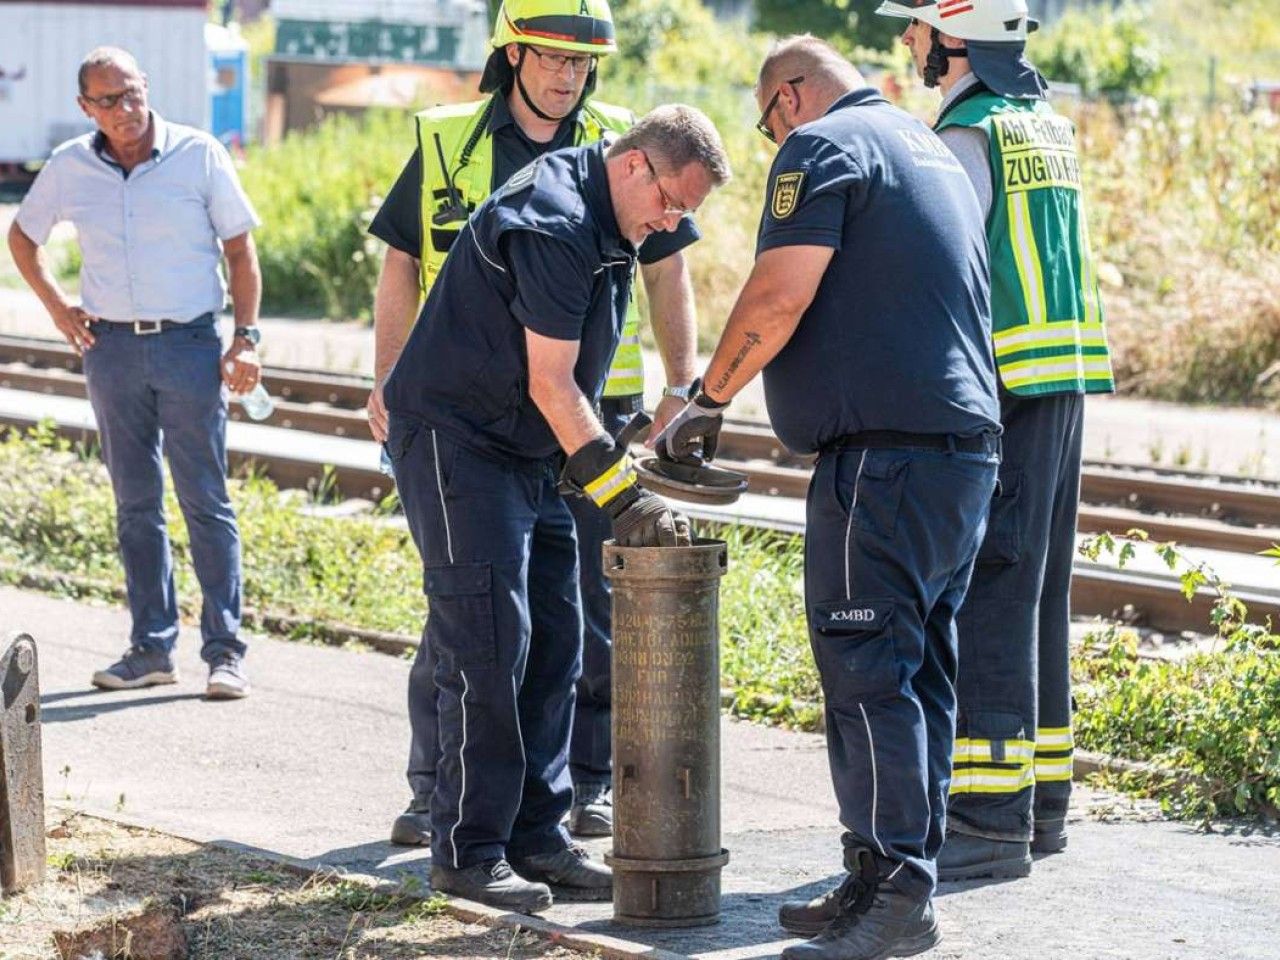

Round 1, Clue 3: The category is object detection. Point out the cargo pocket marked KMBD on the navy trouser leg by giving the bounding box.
[810,600,899,705]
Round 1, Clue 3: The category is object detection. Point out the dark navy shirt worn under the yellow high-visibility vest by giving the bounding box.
[369,93,701,264]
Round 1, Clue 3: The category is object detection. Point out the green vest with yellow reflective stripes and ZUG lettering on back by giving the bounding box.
[937,92,1115,396]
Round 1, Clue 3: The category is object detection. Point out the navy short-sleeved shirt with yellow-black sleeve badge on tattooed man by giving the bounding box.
[756,88,1000,453]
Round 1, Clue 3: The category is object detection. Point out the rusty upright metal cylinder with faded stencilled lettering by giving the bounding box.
[604,540,728,927]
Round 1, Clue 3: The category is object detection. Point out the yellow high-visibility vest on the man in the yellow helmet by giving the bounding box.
[417,100,644,397]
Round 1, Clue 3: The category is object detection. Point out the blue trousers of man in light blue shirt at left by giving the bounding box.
[84,314,244,662]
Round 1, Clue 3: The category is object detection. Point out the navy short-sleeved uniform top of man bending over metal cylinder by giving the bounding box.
[384,143,636,460]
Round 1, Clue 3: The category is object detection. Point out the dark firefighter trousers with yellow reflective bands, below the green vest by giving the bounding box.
[948,393,1084,841]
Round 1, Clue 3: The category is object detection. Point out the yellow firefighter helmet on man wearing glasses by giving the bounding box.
[480,0,618,91]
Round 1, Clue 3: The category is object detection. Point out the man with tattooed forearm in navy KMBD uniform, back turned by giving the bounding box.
[653,36,1000,960]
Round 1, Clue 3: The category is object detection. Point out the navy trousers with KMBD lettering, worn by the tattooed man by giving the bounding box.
[805,438,998,899]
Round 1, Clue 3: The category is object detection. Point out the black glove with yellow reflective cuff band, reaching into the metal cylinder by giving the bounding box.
[561,436,690,547]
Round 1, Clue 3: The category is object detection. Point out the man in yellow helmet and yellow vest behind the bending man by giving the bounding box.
[369,0,699,845]
